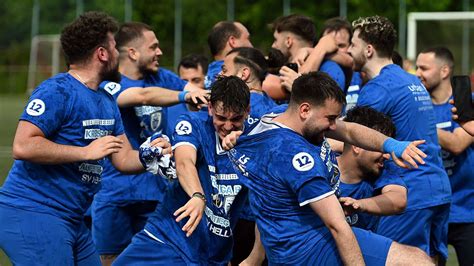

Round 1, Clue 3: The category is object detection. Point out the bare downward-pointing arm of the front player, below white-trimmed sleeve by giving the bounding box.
[310,194,365,265]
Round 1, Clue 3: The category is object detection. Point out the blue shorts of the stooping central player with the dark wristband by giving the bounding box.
[113,230,189,266]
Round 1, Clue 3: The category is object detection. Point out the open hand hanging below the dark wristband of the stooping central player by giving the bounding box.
[173,197,206,237]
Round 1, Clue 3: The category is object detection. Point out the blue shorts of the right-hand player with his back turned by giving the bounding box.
[377,204,450,259]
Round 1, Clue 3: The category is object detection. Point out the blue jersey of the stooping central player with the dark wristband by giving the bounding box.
[145,112,247,264]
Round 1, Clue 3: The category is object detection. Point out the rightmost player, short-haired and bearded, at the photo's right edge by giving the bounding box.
[416,47,474,265]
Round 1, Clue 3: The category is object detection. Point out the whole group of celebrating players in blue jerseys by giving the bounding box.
[0,9,474,265]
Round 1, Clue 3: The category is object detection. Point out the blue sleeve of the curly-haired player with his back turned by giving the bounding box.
[357,81,391,113]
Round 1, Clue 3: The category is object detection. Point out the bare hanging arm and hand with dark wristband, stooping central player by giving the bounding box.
[174,145,207,237]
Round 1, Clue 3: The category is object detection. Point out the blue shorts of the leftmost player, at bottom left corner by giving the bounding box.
[0,204,101,266]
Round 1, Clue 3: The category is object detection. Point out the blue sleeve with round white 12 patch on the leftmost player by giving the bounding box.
[20,82,70,137]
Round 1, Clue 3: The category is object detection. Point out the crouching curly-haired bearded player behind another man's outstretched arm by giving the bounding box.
[337,106,407,231]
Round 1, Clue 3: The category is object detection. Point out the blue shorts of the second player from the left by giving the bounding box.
[91,200,158,255]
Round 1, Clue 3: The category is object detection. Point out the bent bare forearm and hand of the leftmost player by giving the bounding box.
[13,121,123,164]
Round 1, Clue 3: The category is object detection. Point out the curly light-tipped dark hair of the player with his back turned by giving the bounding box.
[352,16,397,58]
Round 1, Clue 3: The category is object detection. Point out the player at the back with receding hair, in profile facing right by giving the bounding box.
[204,21,253,88]
